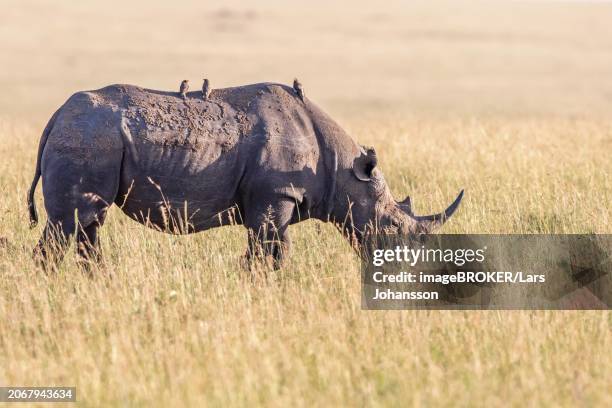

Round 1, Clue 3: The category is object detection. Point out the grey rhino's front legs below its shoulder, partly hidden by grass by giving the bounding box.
[245,198,295,269]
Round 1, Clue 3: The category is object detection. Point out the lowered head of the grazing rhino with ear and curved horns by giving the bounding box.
[338,148,463,243]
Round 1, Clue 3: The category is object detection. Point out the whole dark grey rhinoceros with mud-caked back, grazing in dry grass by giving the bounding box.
[28,83,462,267]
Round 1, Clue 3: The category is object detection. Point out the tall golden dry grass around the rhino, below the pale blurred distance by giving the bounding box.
[0,118,611,405]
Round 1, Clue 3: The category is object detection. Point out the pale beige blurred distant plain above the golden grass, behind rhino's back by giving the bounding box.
[0,0,612,121]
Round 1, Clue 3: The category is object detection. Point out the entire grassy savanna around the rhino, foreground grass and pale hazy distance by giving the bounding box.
[0,2,612,406]
